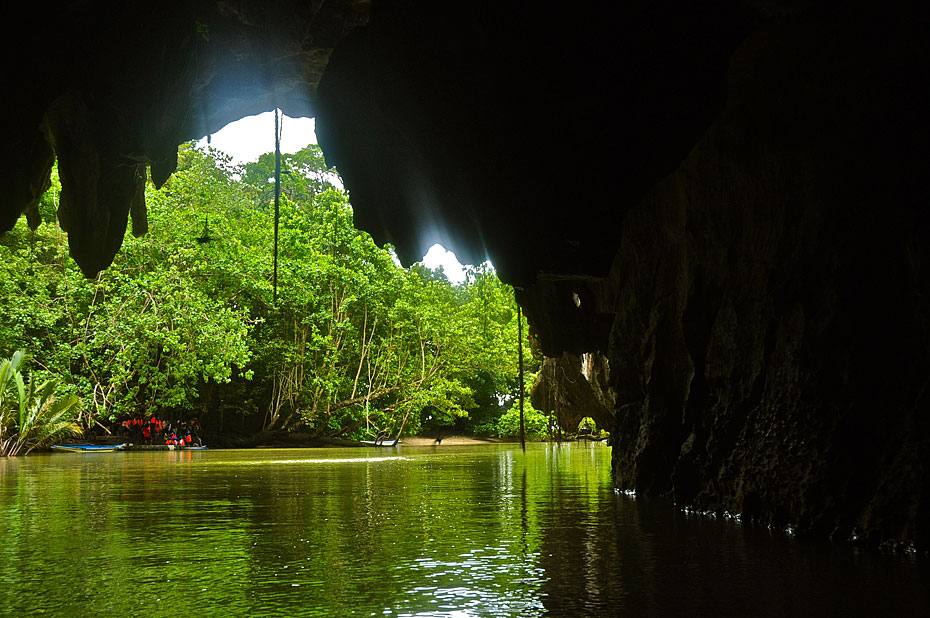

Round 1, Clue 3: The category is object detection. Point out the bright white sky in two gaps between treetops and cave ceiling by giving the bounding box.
[197,111,465,276]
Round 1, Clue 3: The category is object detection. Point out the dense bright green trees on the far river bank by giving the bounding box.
[0,146,533,438]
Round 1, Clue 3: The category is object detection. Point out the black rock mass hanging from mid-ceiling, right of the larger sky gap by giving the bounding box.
[317,0,748,286]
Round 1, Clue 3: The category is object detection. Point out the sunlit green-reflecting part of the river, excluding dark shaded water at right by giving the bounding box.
[0,444,616,616]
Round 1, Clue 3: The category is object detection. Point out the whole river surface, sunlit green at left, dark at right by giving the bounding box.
[0,443,930,617]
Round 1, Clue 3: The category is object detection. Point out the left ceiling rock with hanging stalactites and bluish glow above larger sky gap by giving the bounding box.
[0,0,369,276]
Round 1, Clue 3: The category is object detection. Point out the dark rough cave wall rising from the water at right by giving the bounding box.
[603,27,930,544]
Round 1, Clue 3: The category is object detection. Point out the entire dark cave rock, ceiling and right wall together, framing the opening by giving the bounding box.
[0,0,930,547]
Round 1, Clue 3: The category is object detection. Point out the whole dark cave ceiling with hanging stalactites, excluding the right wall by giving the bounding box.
[0,0,924,350]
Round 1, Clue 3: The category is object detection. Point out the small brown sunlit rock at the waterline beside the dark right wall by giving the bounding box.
[530,352,616,434]
